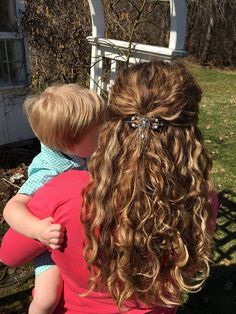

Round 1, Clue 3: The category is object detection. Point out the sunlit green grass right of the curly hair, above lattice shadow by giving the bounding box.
[190,66,236,193]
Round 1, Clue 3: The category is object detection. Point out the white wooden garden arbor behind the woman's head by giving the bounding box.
[87,0,187,93]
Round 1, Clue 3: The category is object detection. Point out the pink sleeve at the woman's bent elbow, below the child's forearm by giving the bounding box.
[0,228,46,266]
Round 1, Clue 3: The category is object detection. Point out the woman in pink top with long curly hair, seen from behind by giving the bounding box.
[0,61,217,314]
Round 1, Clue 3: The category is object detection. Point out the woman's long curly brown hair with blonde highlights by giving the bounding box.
[81,61,215,308]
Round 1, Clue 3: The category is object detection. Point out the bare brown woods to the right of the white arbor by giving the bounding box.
[186,0,236,66]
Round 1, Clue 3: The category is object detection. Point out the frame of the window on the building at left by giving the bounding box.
[0,0,31,90]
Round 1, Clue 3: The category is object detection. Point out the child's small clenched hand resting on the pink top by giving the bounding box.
[35,217,65,250]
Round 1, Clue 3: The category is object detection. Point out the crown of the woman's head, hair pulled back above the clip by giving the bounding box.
[109,62,202,125]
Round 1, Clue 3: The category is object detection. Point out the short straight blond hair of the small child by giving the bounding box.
[24,84,105,151]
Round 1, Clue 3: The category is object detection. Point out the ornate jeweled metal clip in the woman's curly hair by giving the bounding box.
[127,115,164,139]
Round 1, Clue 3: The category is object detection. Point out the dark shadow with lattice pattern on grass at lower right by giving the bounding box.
[177,190,236,314]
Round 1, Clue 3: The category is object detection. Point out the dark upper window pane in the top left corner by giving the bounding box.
[0,0,16,32]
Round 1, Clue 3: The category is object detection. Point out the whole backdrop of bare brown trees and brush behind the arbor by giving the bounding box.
[23,0,236,89]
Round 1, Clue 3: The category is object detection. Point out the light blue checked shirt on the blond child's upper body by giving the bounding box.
[18,143,86,196]
